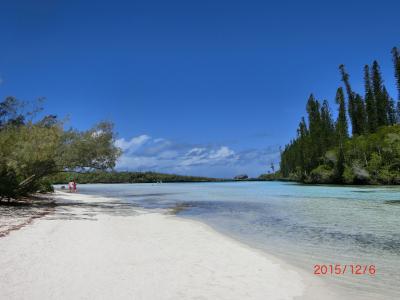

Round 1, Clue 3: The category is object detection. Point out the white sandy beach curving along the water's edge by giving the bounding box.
[0,193,329,300]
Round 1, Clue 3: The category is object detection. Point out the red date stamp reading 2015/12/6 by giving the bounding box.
[314,264,376,276]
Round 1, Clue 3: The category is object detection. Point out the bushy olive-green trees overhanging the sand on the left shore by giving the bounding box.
[0,97,120,204]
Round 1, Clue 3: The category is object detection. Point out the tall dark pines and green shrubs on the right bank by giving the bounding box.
[279,47,400,184]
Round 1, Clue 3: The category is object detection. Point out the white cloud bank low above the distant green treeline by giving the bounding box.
[116,134,279,177]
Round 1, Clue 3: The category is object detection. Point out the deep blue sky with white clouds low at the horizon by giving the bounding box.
[0,0,400,177]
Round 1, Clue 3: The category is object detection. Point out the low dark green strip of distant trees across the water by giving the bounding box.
[50,171,221,184]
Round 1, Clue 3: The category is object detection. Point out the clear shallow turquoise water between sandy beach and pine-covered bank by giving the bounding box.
[79,182,400,299]
